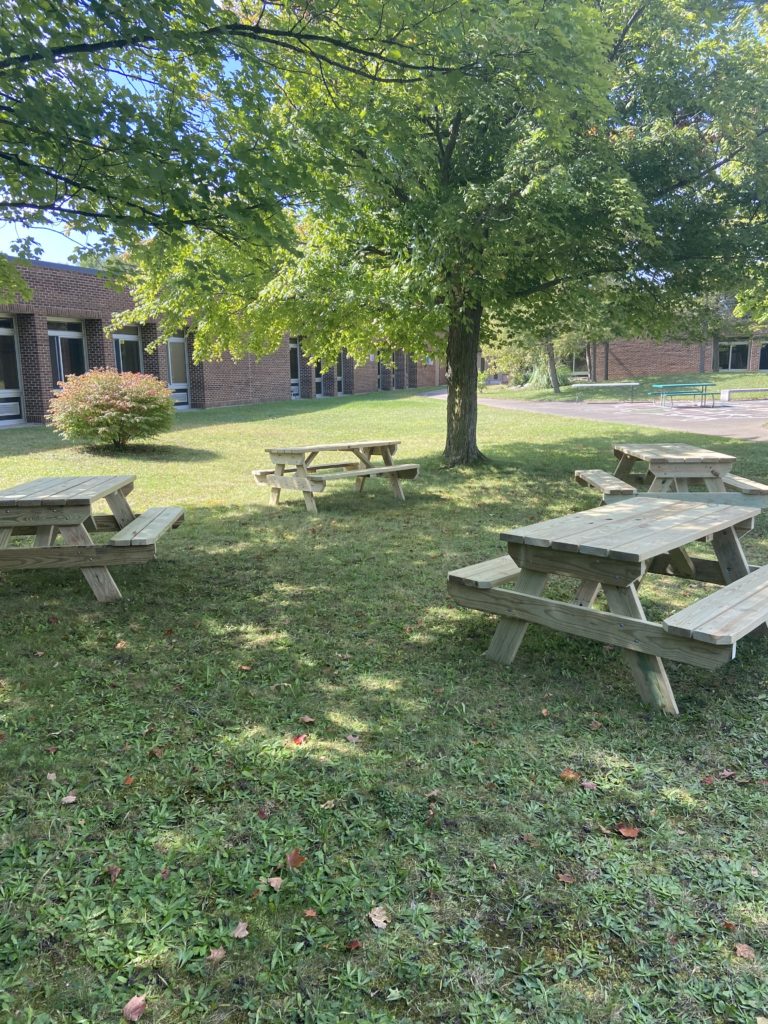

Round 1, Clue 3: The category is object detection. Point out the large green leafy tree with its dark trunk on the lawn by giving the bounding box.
[121,0,768,464]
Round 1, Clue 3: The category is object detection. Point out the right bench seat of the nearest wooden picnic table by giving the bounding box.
[664,565,768,645]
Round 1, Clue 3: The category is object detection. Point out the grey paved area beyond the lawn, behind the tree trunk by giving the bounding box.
[430,391,768,441]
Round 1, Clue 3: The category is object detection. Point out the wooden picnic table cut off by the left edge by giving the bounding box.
[0,476,183,602]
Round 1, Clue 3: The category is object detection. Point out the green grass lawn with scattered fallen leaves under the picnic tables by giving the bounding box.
[0,393,768,1024]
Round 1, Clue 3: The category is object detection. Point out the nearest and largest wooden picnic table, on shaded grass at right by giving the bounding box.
[449,496,768,714]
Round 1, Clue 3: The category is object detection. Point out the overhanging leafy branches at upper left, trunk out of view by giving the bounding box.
[0,0,462,294]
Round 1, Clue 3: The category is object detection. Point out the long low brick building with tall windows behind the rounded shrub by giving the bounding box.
[0,261,445,425]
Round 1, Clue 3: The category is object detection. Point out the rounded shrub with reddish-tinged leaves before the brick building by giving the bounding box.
[48,370,173,447]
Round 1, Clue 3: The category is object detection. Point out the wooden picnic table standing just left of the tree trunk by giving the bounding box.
[253,440,419,513]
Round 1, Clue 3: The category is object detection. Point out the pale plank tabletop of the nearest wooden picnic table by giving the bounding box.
[501,498,755,562]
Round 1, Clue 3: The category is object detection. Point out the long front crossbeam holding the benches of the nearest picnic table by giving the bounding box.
[449,583,735,670]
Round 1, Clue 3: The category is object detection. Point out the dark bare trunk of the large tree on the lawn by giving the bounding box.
[442,305,483,466]
